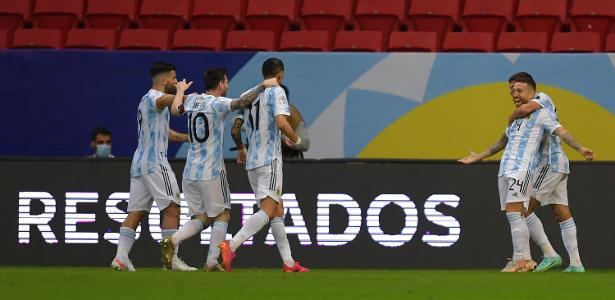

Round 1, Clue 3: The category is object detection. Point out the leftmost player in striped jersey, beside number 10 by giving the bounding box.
[111,62,191,271]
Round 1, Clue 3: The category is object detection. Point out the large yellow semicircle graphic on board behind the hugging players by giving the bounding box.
[358,82,615,160]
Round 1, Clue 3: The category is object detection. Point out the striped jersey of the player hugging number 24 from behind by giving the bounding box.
[531,93,570,174]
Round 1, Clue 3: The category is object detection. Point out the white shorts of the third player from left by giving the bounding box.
[248,159,282,207]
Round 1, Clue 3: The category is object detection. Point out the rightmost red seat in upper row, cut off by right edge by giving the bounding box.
[570,0,615,37]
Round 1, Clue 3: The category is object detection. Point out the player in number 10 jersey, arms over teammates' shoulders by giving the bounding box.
[162,68,278,271]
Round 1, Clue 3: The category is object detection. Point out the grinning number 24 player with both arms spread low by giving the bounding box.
[460,72,593,272]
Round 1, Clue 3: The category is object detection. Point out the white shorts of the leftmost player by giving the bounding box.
[127,165,180,212]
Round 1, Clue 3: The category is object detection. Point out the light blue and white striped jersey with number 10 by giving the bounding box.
[184,94,233,180]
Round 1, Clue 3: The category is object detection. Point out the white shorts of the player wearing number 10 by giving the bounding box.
[182,171,231,218]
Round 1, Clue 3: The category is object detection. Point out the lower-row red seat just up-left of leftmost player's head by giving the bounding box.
[117,29,169,50]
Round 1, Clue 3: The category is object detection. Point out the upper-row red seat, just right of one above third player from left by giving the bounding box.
[301,0,353,40]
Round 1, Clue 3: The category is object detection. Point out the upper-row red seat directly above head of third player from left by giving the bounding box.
[245,0,296,41]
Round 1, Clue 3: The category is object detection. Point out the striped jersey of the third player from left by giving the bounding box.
[238,86,290,170]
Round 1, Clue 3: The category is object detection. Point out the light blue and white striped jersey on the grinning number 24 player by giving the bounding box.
[498,109,561,176]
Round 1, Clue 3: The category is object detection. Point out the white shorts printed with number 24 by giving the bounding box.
[498,172,532,210]
